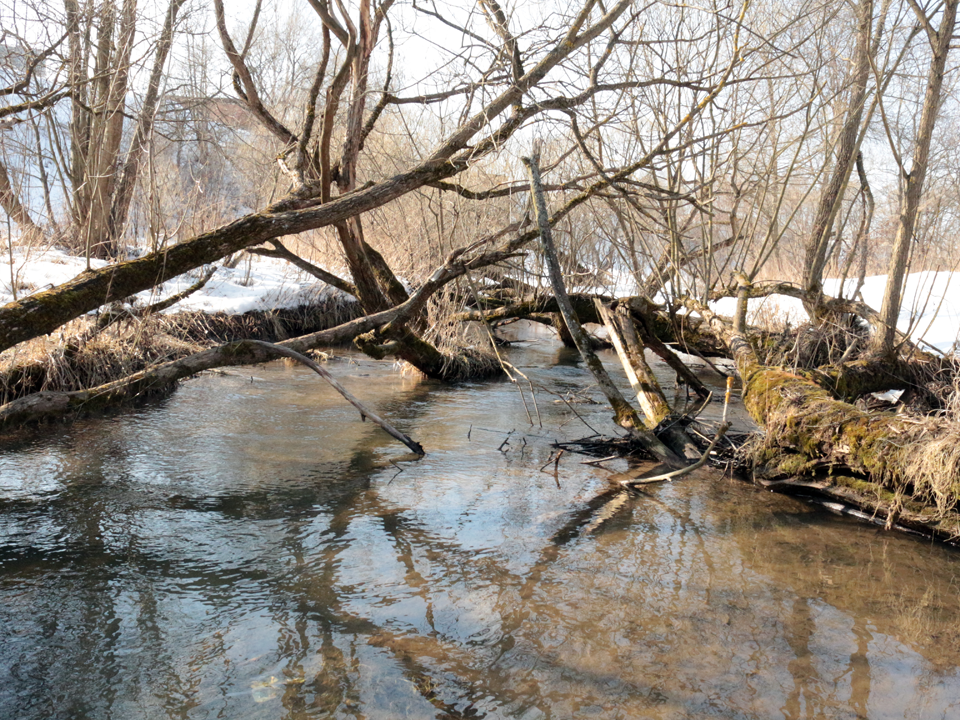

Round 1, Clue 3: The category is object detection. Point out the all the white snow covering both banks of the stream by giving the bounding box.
[0,250,960,352]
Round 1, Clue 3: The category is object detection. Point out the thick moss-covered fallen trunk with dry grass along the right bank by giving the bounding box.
[685,300,960,535]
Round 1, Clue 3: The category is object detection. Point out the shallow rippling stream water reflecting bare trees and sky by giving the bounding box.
[0,345,960,720]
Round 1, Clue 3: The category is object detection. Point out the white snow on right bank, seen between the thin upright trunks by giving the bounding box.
[711,271,960,352]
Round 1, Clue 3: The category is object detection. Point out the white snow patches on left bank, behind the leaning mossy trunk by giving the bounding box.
[0,250,352,315]
